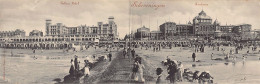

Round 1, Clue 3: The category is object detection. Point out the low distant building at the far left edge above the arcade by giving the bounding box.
[0,29,25,38]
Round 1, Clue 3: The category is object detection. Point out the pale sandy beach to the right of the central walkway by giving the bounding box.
[136,46,260,84]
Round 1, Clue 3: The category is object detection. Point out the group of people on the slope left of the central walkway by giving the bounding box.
[64,52,112,83]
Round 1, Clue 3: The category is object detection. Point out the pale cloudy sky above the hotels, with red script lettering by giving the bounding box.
[0,0,260,38]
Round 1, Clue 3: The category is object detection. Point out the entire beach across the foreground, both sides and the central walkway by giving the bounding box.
[0,46,260,84]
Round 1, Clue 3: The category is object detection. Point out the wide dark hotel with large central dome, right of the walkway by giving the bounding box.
[133,10,254,40]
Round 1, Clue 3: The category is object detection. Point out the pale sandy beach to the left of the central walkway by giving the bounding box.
[0,48,115,84]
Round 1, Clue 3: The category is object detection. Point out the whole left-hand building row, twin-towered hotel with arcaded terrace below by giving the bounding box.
[0,16,118,49]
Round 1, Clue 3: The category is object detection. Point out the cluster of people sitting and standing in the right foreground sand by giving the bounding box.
[161,57,213,83]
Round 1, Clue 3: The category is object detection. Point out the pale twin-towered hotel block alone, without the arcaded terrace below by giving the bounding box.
[46,16,118,41]
